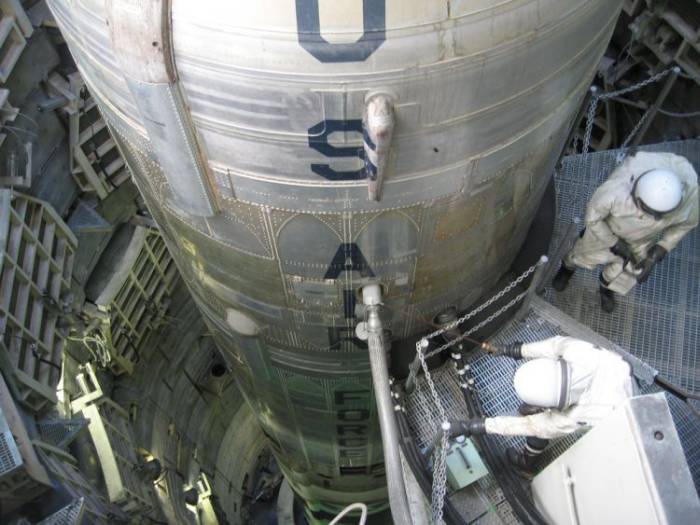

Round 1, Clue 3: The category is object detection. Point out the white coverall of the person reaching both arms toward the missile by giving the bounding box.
[484,336,634,439]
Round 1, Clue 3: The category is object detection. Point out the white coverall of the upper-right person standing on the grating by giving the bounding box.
[564,152,699,295]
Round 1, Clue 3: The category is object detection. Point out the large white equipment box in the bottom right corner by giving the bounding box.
[532,394,700,525]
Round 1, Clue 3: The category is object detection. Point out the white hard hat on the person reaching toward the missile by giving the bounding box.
[513,359,570,409]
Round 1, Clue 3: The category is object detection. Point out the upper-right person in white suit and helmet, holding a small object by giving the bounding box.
[552,152,699,312]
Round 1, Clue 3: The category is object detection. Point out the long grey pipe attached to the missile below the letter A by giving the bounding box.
[362,284,413,525]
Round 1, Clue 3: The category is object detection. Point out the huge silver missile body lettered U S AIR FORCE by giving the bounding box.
[49,0,621,512]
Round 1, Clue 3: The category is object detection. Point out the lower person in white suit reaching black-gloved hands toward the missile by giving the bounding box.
[450,336,635,474]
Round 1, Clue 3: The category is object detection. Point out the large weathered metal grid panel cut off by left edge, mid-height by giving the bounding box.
[0,190,77,412]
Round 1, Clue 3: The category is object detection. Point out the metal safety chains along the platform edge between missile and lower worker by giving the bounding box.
[409,263,538,525]
